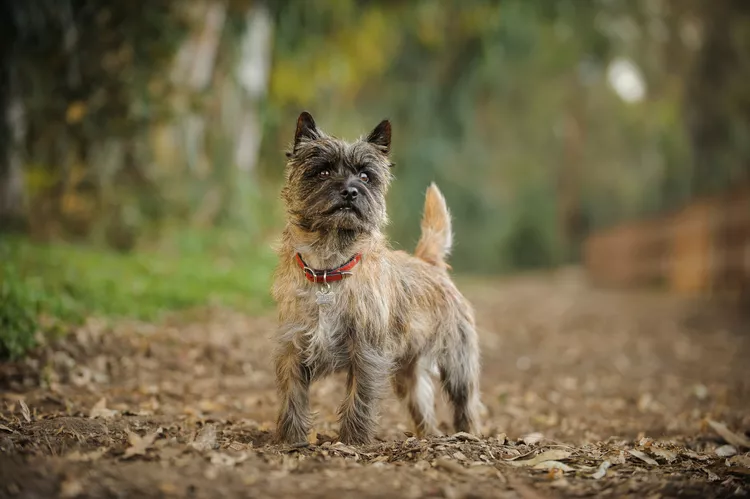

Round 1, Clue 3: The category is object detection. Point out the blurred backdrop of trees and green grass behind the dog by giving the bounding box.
[0,0,750,360]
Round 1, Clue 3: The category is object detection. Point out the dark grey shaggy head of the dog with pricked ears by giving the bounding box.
[282,112,392,233]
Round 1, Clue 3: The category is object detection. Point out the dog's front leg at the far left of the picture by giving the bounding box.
[276,342,312,443]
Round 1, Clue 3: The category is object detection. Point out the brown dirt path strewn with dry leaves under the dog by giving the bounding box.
[0,274,750,498]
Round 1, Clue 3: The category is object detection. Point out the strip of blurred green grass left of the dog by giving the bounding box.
[0,231,275,358]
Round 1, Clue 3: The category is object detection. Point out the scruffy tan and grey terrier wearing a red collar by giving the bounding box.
[273,112,481,444]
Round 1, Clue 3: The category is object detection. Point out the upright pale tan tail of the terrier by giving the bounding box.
[414,183,453,268]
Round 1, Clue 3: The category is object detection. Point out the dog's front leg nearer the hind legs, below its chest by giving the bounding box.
[339,345,389,444]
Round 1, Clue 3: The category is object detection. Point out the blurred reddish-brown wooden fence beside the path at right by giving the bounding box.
[584,185,750,306]
